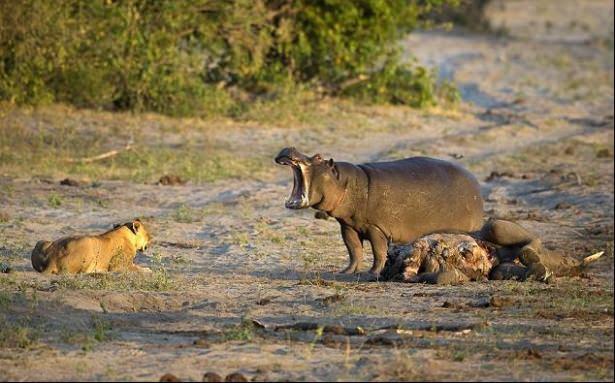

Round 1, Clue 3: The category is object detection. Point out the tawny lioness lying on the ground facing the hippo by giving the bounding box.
[31,219,150,274]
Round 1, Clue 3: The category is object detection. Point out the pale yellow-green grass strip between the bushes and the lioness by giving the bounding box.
[0,106,271,184]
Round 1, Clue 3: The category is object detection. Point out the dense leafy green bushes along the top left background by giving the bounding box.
[0,0,458,115]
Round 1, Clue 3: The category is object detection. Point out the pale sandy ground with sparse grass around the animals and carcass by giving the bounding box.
[0,0,614,381]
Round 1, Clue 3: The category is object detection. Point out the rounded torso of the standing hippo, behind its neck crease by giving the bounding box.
[359,157,483,242]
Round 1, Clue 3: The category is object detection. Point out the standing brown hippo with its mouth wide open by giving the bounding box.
[275,147,483,276]
